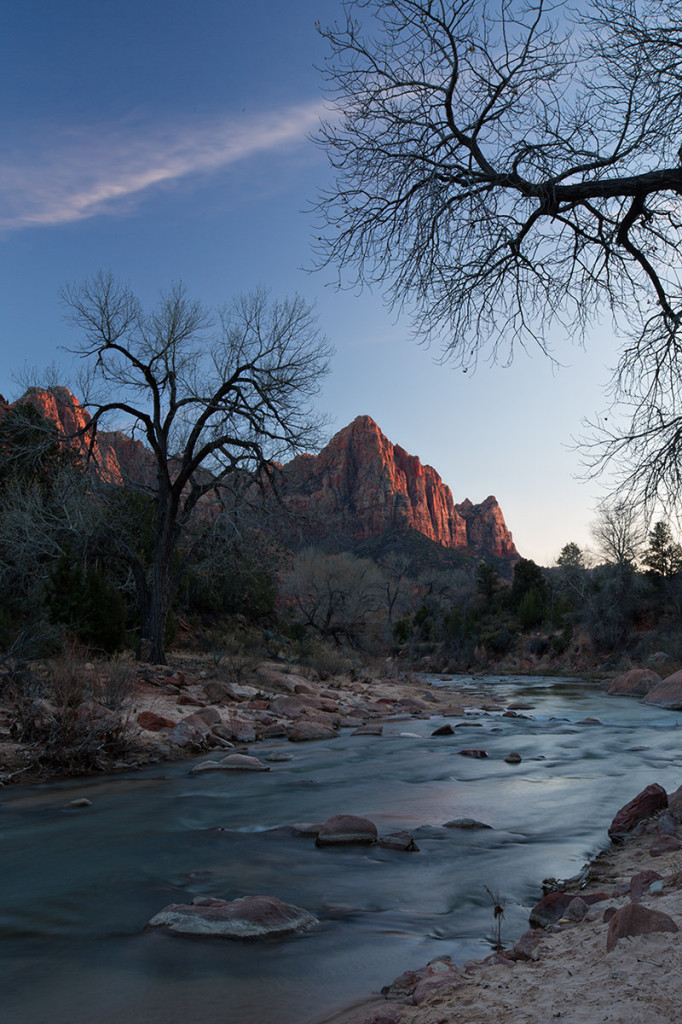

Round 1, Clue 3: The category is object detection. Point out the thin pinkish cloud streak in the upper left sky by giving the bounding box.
[0,102,324,231]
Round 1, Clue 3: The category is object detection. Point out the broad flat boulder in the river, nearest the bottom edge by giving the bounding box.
[148,896,317,939]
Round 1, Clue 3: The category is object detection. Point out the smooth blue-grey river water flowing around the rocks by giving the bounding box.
[0,677,682,1024]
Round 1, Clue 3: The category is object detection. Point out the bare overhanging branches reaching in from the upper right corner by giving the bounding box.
[317,0,682,375]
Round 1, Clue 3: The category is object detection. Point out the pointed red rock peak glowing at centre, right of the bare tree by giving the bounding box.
[280,416,518,558]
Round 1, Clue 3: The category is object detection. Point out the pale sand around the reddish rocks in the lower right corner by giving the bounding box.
[321,835,682,1024]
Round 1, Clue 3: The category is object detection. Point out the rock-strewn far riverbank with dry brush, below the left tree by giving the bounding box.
[0,653,491,785]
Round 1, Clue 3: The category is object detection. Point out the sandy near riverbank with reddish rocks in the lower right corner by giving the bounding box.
[321,786,682,1024]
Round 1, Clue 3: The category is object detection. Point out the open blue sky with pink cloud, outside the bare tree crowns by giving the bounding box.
[0,0,616,565]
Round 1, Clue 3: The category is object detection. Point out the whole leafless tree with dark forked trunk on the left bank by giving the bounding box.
[62,272,331,663]
